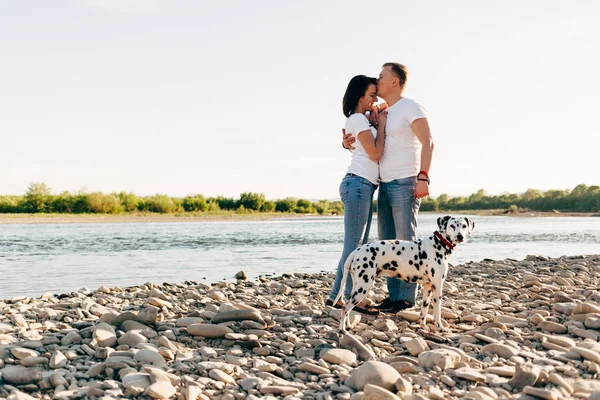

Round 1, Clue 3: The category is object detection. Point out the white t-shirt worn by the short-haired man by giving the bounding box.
[379,97,427,183]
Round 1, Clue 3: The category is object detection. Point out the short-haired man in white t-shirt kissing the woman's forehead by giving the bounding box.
[343,62,433,313]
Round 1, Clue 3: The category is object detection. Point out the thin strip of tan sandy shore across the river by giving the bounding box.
[0,210,600,225]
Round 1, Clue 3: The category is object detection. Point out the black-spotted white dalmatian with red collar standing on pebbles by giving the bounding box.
[333,215,475,334]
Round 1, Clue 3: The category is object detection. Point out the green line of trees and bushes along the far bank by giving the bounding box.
[0,183,600,215]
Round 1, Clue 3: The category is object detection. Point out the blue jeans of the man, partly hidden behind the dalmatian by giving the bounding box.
[377,176,421,304]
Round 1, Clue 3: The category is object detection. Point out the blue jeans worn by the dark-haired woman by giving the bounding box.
[329,174,377,300]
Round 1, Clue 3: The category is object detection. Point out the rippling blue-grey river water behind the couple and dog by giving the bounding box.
[0,214,600,299]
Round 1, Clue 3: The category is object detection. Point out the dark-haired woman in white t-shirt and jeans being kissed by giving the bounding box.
[325,75,387,315]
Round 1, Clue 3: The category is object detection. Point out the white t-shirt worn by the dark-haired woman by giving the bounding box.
[345,113,379,185]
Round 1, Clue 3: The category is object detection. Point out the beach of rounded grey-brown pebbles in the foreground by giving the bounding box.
[0,255,600,400]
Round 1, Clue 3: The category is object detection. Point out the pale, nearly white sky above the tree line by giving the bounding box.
[0,0,600,199]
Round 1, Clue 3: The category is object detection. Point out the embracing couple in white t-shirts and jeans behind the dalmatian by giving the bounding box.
[326,62,433,315]
